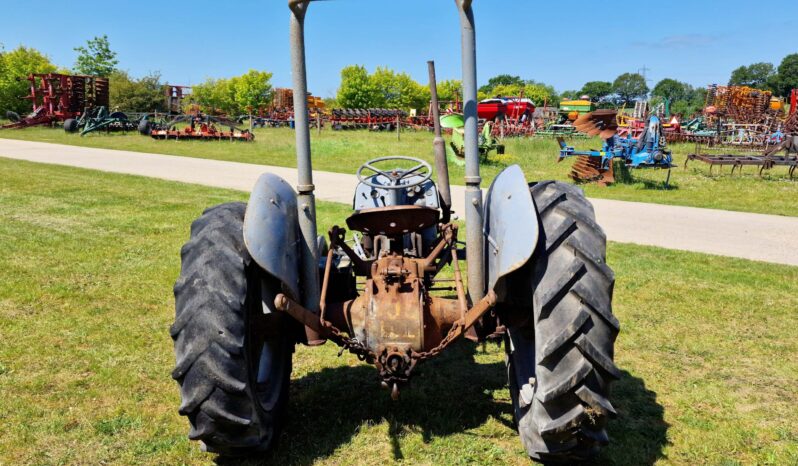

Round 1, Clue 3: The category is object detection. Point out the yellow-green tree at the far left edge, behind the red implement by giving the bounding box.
[0,46,56,115]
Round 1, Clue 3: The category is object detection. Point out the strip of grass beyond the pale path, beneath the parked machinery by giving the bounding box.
[0,128,798,216]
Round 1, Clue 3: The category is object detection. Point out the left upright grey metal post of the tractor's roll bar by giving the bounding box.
[288,0,323,345]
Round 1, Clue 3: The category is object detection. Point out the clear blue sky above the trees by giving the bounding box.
[0,0,798,97]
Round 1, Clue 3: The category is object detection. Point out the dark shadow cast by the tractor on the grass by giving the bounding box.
[217,341,667,465]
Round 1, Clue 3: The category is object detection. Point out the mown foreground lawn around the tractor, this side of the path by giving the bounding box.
[0,158,798,465]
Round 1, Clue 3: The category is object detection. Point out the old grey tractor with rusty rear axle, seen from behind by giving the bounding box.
[171,0,620,462]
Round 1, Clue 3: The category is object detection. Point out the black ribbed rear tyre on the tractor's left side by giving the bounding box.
[170,203,294,456]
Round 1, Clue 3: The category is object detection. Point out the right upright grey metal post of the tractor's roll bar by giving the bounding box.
[455,0,485,303]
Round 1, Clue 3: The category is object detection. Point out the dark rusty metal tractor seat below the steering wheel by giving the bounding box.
[346,205,440,236]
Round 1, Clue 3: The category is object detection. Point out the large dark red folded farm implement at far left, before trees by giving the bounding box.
[0,73,108,128]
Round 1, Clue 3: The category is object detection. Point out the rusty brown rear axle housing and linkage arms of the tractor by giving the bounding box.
[274,218,496,397]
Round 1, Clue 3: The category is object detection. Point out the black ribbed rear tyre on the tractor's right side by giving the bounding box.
[506,181,621,463]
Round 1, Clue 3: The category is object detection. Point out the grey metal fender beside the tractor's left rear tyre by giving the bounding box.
[244,173,300,299]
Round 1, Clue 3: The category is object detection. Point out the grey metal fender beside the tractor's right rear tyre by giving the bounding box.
[483,165,540,302]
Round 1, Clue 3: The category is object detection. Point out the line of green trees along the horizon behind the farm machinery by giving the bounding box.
[0,36,798,115]
